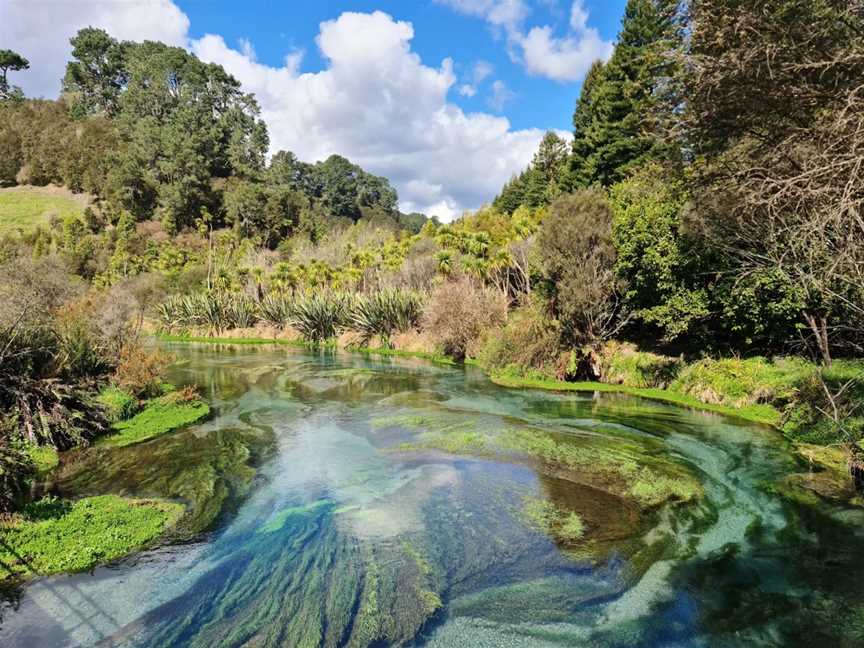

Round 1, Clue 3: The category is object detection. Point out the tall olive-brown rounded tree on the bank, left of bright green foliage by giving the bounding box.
[537,189,625,346]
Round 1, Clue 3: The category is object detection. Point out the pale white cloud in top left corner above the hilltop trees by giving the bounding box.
[0,0,189,97]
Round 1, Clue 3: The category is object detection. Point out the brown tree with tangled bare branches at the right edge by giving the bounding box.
[685,0,864,365]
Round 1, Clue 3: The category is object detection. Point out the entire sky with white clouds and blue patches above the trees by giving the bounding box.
[0,0,625,221]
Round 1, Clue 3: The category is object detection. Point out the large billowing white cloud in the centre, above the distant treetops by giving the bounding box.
[192,12,543,220]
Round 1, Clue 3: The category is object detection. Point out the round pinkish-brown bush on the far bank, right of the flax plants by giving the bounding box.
[421,277,507,360]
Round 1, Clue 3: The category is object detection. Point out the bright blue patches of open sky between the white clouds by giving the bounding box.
[176,0,625,130]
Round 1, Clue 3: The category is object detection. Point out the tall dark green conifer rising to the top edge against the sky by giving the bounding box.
[571,0,680,186]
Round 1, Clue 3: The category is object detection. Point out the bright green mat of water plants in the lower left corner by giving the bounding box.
[0,495,183,581]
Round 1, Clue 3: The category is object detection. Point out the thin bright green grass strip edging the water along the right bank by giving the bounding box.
[491,373,782,427]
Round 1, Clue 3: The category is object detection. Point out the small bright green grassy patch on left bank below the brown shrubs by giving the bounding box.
[97,393,210,448]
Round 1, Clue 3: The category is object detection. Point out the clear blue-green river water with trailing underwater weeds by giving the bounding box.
[0,345,864,648]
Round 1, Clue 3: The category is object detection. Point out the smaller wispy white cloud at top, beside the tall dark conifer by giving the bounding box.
[437,0,612,82]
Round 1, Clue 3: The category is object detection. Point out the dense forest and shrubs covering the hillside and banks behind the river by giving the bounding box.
[0,0,864,509]
